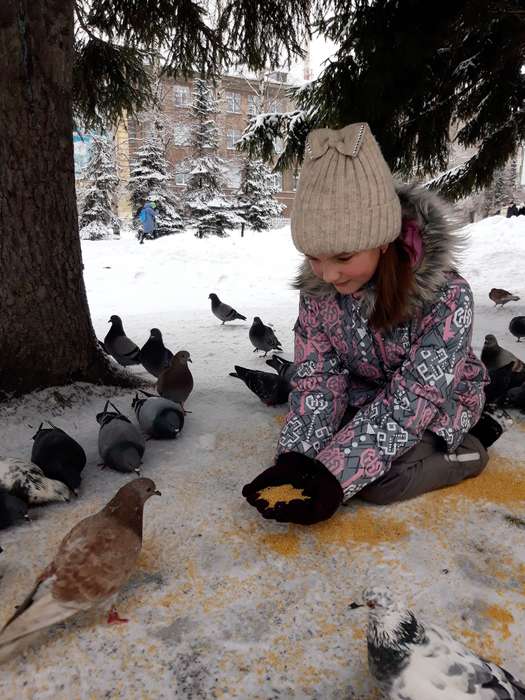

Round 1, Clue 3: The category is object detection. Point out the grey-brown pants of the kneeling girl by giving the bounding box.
[358,430,488,505]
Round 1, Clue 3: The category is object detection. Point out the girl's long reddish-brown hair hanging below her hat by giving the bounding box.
[370,238,415,331]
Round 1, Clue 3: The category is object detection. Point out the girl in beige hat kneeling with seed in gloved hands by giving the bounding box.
[243,124,505,524]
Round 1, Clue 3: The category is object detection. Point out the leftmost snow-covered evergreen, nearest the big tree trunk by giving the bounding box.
[79,135,120,241]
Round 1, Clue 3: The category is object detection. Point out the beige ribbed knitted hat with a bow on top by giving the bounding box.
[291,123,401,256]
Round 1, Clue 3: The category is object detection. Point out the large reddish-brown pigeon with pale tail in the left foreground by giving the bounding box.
[0,479,160,661]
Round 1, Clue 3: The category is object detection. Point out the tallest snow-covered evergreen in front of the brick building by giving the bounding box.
[184,78,240,238]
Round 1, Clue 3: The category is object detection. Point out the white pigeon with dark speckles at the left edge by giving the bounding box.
[0,457,71,506]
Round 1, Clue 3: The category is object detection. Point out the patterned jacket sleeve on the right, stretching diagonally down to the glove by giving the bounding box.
[318,281,483,500]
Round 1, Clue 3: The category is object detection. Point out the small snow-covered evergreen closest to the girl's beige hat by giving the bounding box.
[237,158,284,231]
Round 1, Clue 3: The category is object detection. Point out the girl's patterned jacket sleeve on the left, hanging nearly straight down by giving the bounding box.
[278,295,348,457]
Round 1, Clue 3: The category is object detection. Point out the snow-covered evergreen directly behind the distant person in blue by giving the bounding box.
[128,120,184,236]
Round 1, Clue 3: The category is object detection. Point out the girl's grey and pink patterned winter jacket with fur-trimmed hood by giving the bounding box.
[278,185,487,500]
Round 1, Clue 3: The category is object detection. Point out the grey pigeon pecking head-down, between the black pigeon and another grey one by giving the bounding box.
[97,401,146,475]
